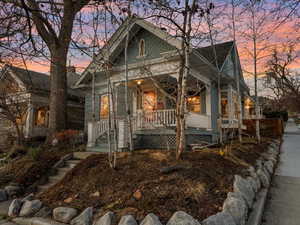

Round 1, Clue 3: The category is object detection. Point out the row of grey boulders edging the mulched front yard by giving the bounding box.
[2,140,280,225]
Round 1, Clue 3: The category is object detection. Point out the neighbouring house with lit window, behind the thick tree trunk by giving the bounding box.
[0,65,84,138]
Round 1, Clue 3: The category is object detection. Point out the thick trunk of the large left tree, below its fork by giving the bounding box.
[49,48,67,135]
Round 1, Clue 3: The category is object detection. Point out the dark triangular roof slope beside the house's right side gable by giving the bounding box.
[196,41,234,69]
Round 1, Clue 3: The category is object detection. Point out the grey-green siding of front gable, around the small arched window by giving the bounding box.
[113,29,175,66]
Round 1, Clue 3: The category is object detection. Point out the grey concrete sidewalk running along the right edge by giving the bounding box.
[262,122,300,225]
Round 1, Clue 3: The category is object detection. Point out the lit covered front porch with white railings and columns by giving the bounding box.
[88,75,212,147]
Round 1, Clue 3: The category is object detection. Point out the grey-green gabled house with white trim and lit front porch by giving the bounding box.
[75,18,254,151]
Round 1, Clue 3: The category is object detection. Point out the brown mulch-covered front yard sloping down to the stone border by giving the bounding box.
[40,139,268,223]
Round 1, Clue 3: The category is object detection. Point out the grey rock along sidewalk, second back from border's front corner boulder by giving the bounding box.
[233,175,255,208]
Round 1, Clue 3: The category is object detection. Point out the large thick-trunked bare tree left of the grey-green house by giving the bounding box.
[1,0,90,137]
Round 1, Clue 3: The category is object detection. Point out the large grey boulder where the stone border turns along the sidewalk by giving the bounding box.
[223,197,248,225]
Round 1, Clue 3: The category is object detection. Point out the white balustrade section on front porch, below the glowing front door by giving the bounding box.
[133,109,176,130]
